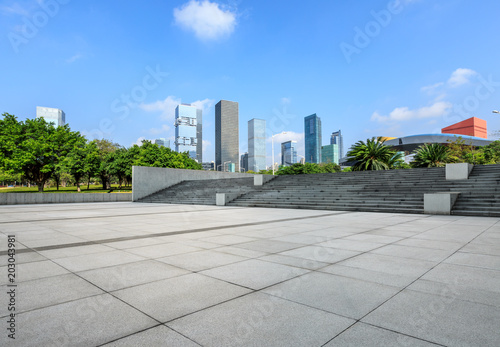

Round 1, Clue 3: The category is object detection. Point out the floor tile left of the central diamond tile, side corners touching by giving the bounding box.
[78,260,190,291]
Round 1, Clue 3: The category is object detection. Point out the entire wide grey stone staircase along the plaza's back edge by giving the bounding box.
[137,165,500,217]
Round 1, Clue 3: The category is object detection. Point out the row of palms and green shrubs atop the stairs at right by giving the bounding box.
[347,137,500,171]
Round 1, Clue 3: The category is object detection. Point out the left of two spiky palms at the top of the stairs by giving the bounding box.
[347,137,399,171]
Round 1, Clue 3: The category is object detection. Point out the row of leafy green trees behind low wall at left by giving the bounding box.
[0,113,202,192]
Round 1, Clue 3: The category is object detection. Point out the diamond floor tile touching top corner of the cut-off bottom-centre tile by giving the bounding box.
[201,259,308,289]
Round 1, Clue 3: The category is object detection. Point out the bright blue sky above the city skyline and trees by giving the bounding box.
[0,0,500,164]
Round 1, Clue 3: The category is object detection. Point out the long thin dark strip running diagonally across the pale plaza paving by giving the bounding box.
[0,212,351,256]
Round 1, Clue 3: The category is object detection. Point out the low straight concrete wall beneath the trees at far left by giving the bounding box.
[0,193,132,205]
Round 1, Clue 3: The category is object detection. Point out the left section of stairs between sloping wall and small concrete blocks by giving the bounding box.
[140,177,253,205]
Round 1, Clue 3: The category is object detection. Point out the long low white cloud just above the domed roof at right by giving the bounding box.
[371,101,453,122]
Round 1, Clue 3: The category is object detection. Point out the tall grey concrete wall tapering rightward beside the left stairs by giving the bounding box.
[132,166,255,201]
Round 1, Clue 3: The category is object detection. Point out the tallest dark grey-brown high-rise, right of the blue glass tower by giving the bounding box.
[215,100,240,171]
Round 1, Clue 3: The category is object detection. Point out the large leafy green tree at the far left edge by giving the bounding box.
[0,113,79,192]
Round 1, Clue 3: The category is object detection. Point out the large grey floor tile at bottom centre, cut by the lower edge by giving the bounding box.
[168,293,353,347]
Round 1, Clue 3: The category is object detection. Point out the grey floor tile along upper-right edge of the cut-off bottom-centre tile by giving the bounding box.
[264,272,399,319]
